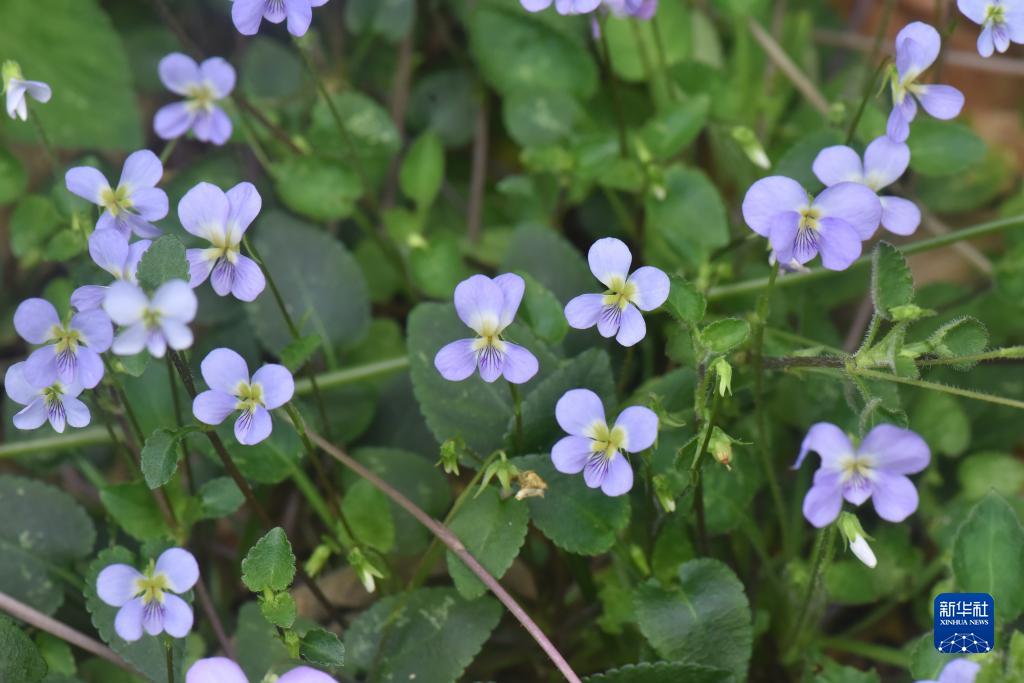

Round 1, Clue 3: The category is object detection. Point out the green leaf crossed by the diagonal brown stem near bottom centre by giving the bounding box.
[447,486,529,600]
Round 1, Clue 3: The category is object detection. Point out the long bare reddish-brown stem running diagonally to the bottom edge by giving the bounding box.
[308,431,580,683]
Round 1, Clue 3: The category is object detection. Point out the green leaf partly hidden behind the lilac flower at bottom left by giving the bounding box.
[85,546,185,683]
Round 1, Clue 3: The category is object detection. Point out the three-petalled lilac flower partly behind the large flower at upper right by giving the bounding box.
[813,135,921,234]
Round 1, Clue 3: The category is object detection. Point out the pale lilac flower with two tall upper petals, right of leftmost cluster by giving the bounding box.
[178,182,266,301]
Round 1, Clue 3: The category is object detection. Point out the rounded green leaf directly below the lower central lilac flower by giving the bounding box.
[512,455,630,555]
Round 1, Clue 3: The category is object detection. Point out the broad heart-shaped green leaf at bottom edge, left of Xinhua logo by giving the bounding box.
[635,559,753,680]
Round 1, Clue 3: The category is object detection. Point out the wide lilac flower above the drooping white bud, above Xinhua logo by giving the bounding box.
[794,422,932,528]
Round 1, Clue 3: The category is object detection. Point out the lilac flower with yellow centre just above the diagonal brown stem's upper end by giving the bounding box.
[193,348,295,445]
